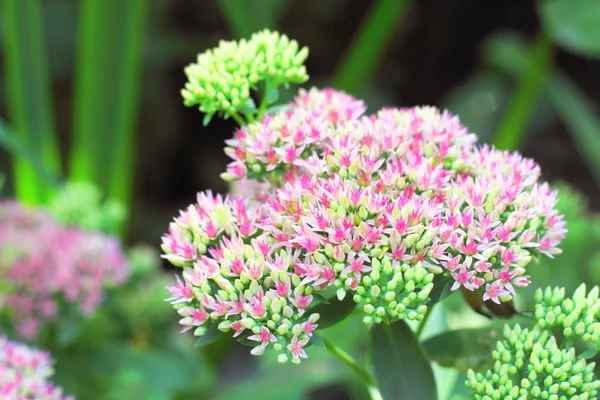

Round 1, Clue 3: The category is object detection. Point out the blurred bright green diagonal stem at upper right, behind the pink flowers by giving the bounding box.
[492,33,552,150]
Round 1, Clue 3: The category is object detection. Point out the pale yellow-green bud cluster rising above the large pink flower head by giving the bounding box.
[181,30,308,121]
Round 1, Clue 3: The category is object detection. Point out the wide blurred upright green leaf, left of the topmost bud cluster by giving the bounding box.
[69,0,148,234]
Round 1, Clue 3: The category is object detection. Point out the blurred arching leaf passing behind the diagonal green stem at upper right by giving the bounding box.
[486,35,600,185]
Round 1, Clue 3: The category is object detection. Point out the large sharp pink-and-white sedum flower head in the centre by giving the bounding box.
[163,89,566,361]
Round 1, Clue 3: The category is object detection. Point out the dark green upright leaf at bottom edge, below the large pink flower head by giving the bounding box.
[370,320,437,400]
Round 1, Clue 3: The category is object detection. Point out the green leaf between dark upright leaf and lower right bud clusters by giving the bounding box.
[423,324,503,371]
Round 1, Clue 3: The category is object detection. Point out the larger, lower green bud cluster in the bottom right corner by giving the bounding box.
[466,325,600,400]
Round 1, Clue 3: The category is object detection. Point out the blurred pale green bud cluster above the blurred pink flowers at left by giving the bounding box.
[50,182,125,233]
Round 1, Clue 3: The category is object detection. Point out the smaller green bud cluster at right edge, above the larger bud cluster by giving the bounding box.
[535,284,600,351]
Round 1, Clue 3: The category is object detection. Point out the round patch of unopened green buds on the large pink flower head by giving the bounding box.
[336,257,434,325]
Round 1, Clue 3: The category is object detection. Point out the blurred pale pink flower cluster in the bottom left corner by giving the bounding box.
[0,336,73,400]
